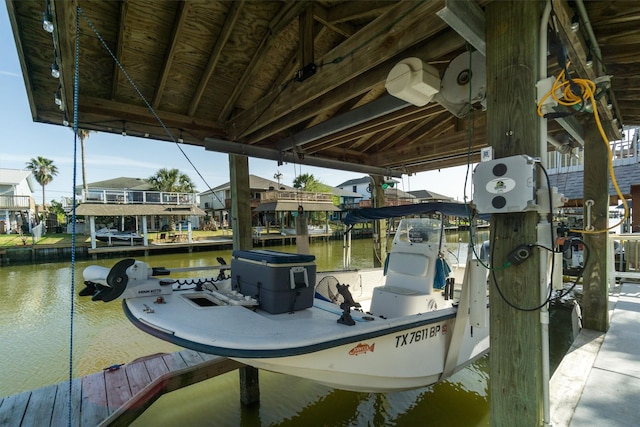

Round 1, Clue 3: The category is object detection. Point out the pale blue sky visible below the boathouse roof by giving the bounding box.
[0,5,471,203]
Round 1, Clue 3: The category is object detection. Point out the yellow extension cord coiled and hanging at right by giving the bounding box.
[538,63,629,234]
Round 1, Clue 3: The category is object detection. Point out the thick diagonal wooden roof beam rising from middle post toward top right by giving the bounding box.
[226,1,446,140]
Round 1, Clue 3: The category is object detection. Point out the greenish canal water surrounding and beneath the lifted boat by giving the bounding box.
[0,235,496,426]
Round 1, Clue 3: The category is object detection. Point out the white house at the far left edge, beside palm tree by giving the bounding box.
[0,169,35,234]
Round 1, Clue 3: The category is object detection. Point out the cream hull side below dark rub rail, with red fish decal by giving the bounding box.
[238,314,489,393]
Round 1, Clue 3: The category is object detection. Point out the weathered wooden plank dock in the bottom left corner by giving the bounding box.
[0,350,244,427]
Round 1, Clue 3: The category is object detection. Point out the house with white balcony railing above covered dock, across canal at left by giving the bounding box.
[76,177,205,248]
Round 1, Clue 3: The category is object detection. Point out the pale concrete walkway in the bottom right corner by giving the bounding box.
[550,283,640,427]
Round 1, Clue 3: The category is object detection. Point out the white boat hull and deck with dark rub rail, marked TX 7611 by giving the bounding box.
[123,291,489,392]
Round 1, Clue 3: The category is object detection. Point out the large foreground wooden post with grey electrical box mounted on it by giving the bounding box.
[486,0,543,426]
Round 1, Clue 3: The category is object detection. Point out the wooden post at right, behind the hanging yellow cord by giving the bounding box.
[582,121,609,332]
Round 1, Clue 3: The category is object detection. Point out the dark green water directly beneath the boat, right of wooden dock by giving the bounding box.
[132,357,489,427]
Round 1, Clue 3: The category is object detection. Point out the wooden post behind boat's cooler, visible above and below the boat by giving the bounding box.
[229,154,260,405]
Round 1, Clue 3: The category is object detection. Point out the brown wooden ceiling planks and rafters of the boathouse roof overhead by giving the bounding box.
[7,0,640,177]
